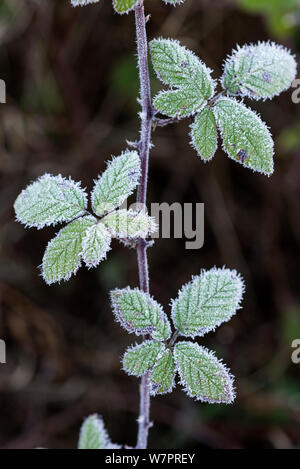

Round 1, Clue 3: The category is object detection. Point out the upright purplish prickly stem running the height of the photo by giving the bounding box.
[135,0,153,449]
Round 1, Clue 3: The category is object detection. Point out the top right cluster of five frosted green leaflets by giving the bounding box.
[150,39,297,175]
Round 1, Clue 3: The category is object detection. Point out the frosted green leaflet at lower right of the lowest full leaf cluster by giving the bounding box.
[174,342,235,404]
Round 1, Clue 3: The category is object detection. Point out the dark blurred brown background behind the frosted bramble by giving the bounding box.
[0,0,300,448]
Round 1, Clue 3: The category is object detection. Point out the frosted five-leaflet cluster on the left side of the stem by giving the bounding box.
[14,151,156,284]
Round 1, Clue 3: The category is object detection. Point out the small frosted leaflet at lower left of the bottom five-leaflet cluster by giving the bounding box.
[123,340,165,377]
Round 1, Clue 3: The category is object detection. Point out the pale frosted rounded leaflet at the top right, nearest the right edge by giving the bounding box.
[222,42,297,99]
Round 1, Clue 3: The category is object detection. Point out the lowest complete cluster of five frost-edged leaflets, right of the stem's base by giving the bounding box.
[116,268,244,404]
